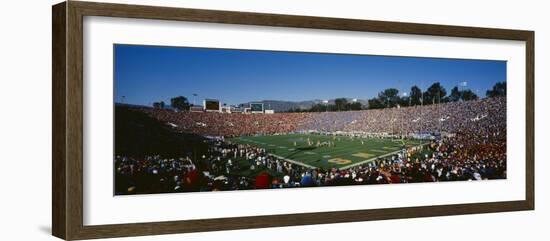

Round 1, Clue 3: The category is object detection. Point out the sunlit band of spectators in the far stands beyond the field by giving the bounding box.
[142,97,506,137]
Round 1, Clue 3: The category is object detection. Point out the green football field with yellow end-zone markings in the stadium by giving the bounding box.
[229,134,422,169]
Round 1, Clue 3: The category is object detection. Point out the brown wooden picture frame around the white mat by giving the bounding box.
[52,1,535,240]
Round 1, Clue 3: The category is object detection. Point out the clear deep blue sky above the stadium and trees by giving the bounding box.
[114,45,506,105]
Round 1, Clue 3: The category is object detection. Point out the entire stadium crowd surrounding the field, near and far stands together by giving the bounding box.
[115,98,506,194]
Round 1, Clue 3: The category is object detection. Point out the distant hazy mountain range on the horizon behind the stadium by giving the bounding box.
[240,98,368,112]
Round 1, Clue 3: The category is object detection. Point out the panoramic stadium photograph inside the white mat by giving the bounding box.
[112,44,507,195]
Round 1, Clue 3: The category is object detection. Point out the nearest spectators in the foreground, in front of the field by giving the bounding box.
[115,137,506,194]
